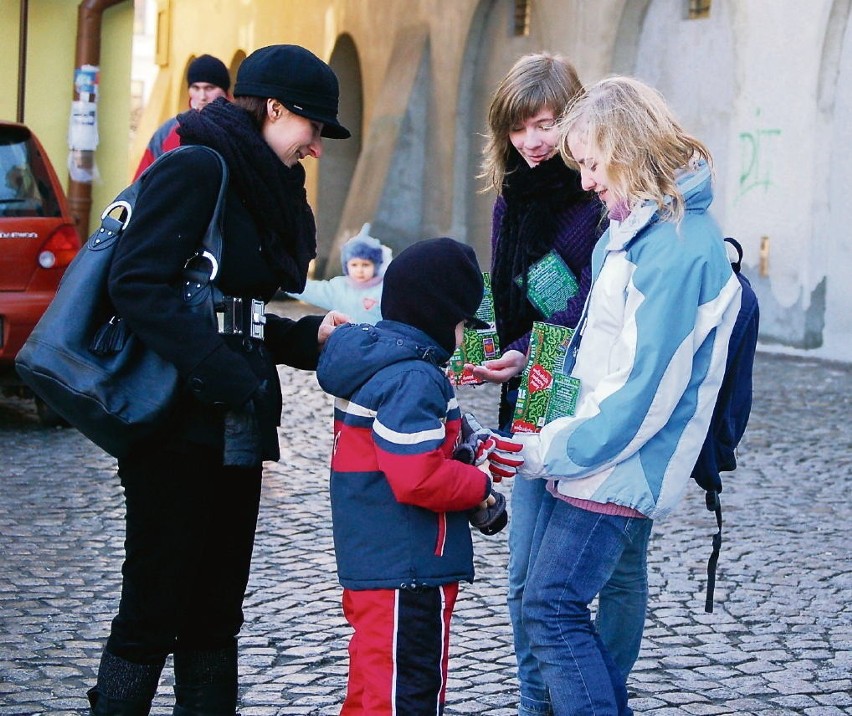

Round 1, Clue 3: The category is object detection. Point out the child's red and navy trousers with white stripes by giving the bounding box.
[340,583,459,716]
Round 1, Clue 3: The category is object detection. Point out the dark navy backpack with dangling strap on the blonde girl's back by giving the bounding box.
[692,237,760,614]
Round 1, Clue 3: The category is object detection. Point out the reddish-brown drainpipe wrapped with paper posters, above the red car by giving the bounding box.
[68,0,125,238]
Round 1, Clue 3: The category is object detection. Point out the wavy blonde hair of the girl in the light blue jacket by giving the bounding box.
[559,77,713,222]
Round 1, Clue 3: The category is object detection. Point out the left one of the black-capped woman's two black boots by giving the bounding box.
[86,651,163,716]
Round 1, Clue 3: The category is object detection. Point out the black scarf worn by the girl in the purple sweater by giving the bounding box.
[491,151,587,346]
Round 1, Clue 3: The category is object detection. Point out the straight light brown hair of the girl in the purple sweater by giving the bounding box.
[477,52,583,193]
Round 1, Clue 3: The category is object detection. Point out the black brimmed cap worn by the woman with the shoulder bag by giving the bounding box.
[234,45,351,139]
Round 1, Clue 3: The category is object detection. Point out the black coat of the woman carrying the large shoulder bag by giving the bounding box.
[109,149,322,454]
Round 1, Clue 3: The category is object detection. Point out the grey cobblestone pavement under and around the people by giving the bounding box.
[0,300,852,716]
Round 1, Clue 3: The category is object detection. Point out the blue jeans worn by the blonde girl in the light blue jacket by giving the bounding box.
[522,495,651,716]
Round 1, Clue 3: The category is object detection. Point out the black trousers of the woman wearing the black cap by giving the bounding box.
[106,446,261,664]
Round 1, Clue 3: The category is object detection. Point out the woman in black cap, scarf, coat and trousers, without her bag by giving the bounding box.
[89,45,349,716]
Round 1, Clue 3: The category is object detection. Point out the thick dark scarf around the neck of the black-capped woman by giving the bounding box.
[178,98,317,293]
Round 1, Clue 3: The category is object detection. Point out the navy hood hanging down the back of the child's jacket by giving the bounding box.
[317,320,450,400]
